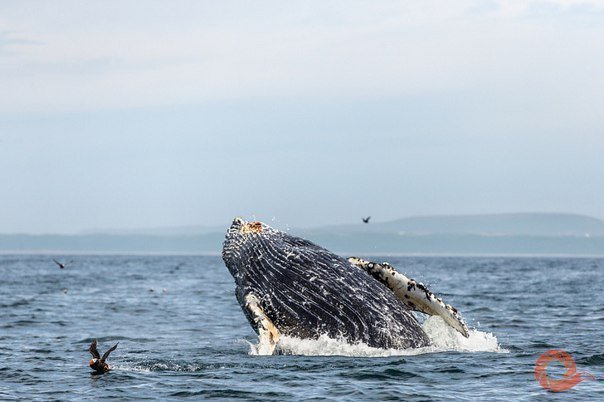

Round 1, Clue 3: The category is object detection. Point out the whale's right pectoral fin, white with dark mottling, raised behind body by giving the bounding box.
[348,257,469,338]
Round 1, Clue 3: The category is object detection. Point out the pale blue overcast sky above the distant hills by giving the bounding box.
[0,0,604,233]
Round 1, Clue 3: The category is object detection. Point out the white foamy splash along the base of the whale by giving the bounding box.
[250,316,508,357]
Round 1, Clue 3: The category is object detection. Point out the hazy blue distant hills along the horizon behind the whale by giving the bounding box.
[0,213,604,255]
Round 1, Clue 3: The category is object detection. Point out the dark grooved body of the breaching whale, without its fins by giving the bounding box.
[222,218,429,349]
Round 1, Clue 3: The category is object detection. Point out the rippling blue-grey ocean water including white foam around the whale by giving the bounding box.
[0,255,604,401]
